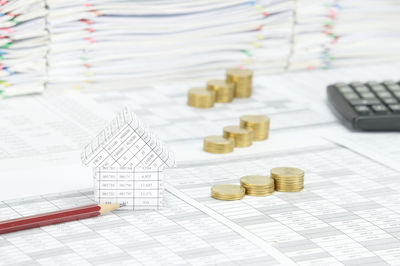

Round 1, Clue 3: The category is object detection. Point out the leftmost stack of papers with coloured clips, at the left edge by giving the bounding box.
[0,0,48,96]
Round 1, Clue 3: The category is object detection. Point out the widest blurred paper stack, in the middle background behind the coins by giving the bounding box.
[48,0,294,89]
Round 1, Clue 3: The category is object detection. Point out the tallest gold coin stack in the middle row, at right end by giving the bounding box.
[240,115,269,140]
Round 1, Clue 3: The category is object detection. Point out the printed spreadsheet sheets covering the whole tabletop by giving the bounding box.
[0,65,400,265]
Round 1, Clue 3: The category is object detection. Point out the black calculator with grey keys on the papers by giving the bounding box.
[327,80,400,131]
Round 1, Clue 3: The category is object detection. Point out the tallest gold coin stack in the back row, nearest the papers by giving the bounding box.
[226,68,253,98]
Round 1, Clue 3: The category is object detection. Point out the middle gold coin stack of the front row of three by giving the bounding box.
[240,175,275,196]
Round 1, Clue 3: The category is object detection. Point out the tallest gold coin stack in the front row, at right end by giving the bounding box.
[271,167,304,192]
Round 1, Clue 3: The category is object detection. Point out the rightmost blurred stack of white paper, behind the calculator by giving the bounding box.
[329,0,400,66]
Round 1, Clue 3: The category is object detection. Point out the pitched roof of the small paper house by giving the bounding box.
[81,108,175,169]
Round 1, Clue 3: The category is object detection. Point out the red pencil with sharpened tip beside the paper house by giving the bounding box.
[0,204,121,234]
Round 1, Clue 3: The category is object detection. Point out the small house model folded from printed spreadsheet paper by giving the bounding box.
[81,109,175,210]
